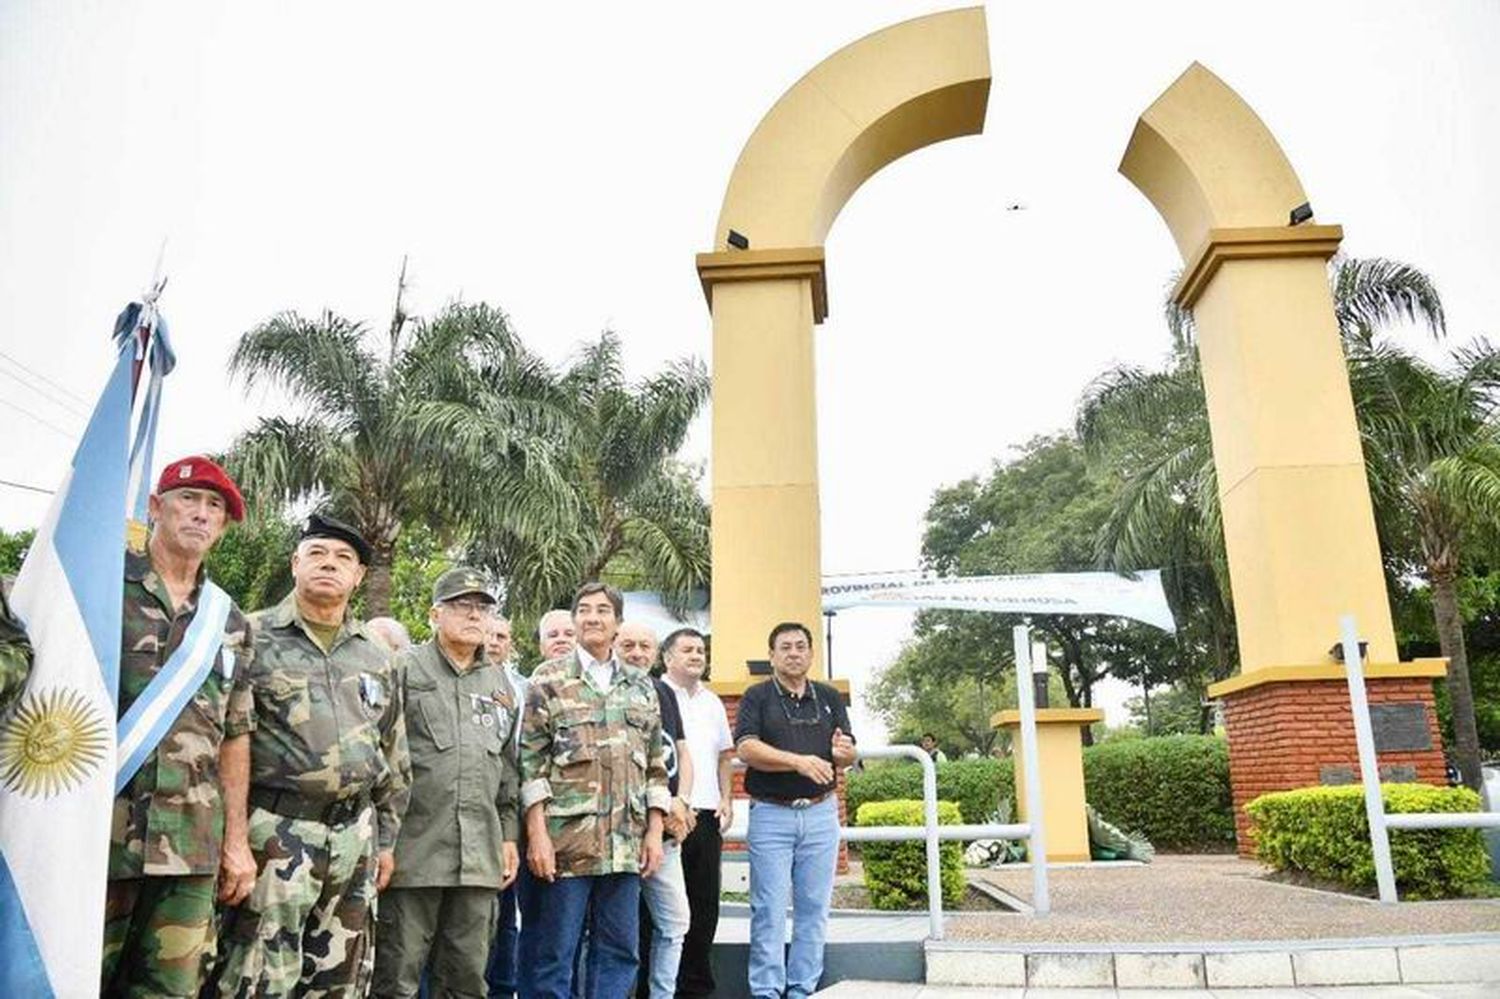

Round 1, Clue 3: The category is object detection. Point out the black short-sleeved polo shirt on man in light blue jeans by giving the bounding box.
[735,677,854,800]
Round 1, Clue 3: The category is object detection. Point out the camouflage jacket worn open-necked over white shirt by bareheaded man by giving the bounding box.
[521,653,672,878]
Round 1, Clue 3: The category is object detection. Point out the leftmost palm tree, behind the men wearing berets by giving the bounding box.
[230,293,573,615]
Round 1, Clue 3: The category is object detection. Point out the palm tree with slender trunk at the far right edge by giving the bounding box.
[1350,341,1500,791]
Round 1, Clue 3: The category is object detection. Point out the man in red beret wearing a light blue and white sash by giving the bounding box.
[101,456,255,996]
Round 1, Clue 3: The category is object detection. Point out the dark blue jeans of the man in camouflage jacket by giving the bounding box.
[521,875,641,999]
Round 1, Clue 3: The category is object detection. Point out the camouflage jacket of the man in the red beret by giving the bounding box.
[110,552,252,879]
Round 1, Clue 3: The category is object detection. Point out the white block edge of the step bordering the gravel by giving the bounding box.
[924,933,1500,996]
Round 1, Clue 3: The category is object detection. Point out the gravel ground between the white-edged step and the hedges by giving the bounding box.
[900,855,1500,944]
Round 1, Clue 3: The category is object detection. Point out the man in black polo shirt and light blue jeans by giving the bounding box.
[735,623,855,999]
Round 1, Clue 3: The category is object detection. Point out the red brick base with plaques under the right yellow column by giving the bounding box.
[1211,668,1448,857]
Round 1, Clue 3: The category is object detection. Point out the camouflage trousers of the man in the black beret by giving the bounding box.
[215,809,377,999]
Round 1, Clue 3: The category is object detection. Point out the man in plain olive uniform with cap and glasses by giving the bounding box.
[375,567,519,999]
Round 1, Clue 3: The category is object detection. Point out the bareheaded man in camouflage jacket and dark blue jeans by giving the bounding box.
[521,582,671,999]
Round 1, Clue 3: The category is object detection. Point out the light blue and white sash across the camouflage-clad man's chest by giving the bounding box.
[114,579,234,794]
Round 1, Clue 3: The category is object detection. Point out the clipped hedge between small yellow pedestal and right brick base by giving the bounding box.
[1083,735,1235,852]
